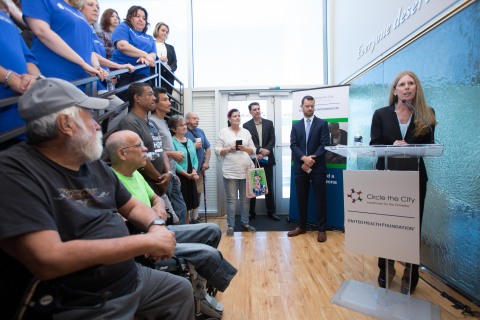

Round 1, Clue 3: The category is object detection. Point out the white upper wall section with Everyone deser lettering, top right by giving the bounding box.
[327,0,468,84]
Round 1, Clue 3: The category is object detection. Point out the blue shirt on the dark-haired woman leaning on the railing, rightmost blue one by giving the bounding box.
[112,22,157,76]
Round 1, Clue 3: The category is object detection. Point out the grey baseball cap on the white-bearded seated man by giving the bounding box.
[18,78,109,122]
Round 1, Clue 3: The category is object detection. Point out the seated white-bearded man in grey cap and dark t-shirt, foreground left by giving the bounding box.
[0,78,194,319]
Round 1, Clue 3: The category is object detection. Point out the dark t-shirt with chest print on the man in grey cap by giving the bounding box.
[0,142,137,314]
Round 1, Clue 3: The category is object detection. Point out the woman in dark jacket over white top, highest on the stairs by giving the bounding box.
[153,22,177,94]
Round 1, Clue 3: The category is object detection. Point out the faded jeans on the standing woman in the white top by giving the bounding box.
[223,178,250,228]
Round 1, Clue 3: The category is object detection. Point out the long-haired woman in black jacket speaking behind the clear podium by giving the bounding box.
[370,71,437,294]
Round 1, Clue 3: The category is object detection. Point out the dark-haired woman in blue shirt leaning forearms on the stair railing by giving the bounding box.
[112,6,157,94]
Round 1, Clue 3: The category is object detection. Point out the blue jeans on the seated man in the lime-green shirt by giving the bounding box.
[168,223,237,292]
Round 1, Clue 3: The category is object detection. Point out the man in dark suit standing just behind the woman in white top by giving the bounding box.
[243,102,280,221]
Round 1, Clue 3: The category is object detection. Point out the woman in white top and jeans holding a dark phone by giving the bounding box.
[215,109,256,236]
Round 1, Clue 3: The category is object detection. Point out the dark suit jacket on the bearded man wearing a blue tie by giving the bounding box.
[290,116,330,173]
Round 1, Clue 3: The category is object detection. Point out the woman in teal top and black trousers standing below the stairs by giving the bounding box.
[168,115,199,223]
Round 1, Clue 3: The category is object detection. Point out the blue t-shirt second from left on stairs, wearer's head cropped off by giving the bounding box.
[21,0,93,81]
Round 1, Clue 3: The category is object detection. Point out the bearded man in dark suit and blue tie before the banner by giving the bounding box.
[288,96,330,242]
